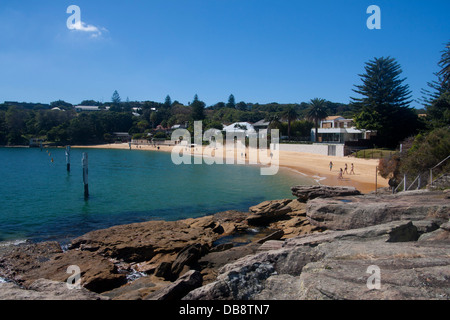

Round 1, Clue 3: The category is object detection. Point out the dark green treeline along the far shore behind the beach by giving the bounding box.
[0,95,352,145]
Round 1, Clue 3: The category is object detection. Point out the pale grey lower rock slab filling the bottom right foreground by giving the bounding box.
[184,222,450,300]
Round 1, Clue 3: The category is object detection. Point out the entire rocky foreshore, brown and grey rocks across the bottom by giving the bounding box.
[0,186,450,300]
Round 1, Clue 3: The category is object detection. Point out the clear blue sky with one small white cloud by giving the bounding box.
[0,0,450,106]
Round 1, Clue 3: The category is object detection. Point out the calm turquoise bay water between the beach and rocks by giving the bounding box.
[0,148,315,243]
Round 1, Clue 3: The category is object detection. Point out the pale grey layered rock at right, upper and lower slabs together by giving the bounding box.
[184,191,450,300]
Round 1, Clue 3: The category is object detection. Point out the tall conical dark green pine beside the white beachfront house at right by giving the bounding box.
[351,57,419,147]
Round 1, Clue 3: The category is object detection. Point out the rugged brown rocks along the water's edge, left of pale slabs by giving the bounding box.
[0,199,315,299]
